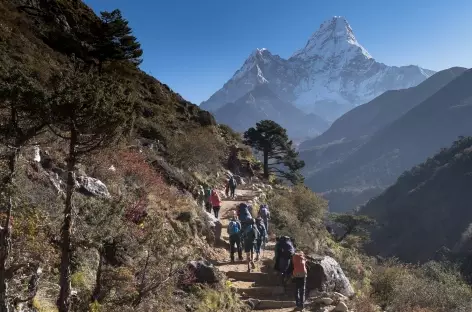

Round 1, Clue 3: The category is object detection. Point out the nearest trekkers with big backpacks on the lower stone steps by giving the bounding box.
[227,203,307,310]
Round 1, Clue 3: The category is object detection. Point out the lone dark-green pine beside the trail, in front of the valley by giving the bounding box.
[244,120,305,184]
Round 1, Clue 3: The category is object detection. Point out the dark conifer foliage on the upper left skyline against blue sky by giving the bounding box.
[94,9,143,65]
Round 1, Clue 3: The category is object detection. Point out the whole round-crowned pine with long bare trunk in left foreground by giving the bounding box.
[47,64,132,312]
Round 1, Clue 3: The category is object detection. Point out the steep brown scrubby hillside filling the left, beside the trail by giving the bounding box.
[0,0,257,312]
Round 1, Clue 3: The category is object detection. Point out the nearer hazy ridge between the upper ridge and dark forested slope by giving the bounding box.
[307,70,472,210]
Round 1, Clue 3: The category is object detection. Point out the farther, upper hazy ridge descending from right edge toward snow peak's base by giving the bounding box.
[299,67,466,177]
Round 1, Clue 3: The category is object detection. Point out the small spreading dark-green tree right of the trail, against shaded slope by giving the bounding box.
[330,214,376,242]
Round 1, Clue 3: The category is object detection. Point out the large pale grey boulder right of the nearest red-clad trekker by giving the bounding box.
[306,255,354,298]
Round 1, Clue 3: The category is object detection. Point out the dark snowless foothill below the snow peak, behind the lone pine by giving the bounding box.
[214,84,329,139]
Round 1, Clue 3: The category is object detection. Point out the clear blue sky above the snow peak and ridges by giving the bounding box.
[85,0,472,104]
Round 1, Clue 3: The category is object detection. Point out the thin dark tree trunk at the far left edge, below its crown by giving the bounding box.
[0,148,18,312]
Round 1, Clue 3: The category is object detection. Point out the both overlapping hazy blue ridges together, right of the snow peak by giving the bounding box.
[300,68,472,211]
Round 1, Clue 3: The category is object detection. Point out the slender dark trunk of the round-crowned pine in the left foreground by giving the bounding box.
[57,129,78,312]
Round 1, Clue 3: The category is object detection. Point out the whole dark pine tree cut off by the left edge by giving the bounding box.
[0,68,46,312]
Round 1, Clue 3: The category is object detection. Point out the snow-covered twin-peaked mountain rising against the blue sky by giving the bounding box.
[201,16,434,121]
